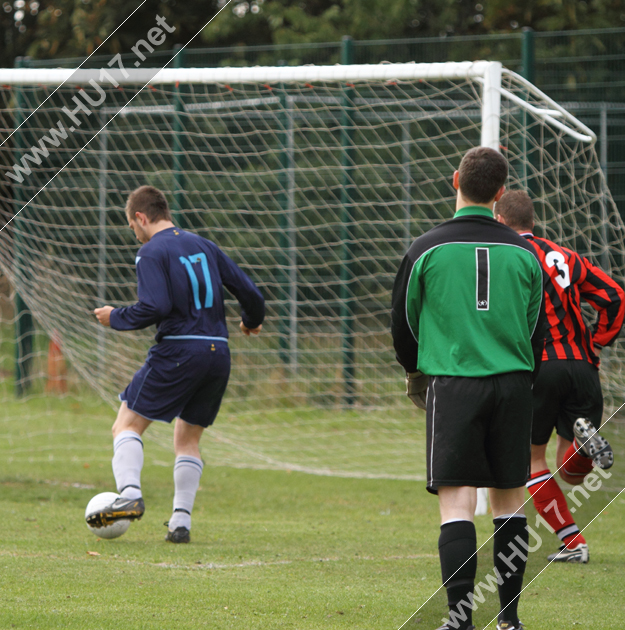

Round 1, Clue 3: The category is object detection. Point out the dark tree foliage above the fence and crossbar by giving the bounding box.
[0,0,625,67]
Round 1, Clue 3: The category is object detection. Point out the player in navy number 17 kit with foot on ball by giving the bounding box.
[87,186,265,543]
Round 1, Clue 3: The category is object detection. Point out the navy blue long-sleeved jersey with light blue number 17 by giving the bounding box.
[111,227,265,341]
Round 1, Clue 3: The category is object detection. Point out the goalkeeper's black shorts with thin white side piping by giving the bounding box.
[426,372,532,494]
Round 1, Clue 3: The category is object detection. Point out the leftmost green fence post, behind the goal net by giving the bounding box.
[13,57,35,398]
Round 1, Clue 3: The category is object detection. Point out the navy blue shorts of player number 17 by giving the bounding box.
[119,339,230,428]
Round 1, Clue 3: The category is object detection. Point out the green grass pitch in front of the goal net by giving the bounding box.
[0,399,625,630]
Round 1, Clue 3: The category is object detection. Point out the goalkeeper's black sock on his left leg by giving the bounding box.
[438,521,477,630]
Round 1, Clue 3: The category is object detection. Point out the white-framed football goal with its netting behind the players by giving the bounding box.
[0,60,625,479]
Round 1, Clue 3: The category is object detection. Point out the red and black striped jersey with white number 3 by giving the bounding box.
[521,232,625,366]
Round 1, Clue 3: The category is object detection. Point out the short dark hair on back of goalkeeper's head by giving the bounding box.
[458,147,508,203]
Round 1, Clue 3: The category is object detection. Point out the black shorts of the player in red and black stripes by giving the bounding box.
[532,360,603,445]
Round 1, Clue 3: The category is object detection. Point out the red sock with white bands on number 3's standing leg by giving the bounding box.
[526,469,586,549]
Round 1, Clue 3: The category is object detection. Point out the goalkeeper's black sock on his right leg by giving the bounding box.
[493,516,529,625]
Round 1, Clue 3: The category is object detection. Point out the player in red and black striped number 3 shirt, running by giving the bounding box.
[495,191,625,563]
